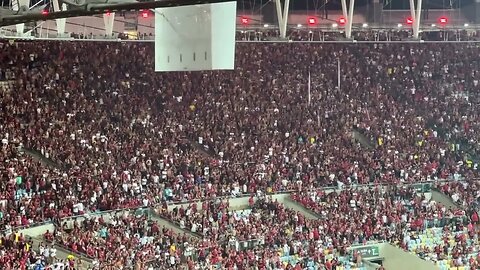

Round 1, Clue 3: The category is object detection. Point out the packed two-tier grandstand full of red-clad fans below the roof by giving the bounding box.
[0,38,480,270]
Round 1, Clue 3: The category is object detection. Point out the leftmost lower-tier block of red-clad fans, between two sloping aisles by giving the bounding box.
[44,214,195,269]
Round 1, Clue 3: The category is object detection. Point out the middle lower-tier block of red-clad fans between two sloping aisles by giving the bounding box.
[158,194,361,269]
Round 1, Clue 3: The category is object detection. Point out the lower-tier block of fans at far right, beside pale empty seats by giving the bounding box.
[292,187,480,269]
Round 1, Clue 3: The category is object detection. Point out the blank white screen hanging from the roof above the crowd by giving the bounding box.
[155,1,237,71]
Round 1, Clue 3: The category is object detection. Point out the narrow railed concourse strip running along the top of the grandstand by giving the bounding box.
[0,28,480,43]
